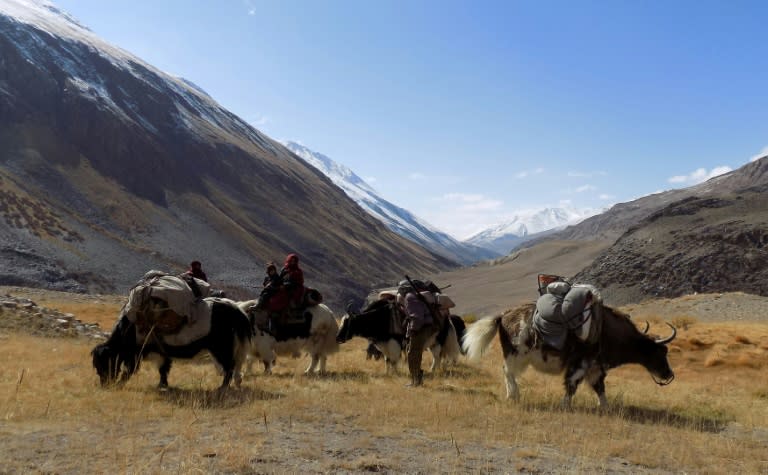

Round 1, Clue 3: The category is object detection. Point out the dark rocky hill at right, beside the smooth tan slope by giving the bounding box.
[575,158,768,303]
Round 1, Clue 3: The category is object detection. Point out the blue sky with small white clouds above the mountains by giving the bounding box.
[54,0,768,238]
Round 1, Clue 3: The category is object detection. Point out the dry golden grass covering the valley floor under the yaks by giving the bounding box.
[0,310,768,473]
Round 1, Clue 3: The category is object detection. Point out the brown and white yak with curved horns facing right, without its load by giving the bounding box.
[462,297,676,408]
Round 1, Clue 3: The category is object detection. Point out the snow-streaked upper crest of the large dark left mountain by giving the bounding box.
[0,0,282,156]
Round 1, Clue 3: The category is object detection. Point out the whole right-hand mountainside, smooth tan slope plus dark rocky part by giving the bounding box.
[429,156,768,317]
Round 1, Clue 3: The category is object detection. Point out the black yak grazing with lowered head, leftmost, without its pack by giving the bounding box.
[91,301,252,389]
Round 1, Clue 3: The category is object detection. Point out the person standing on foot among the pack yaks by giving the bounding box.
[400,281,437,387]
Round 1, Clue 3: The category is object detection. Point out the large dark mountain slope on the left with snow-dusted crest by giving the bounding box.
[0,0,455,304]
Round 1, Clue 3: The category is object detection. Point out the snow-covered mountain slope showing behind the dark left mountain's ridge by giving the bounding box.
[284,141,499,265]
